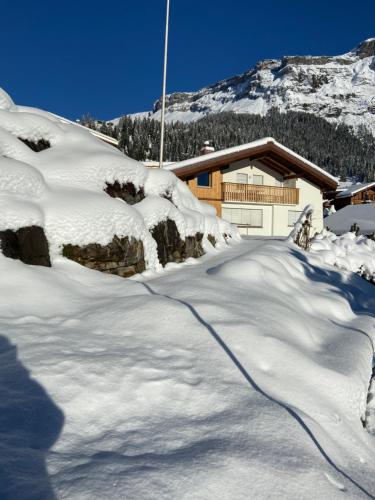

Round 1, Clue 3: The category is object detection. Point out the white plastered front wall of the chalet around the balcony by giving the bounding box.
[222,160,323,236]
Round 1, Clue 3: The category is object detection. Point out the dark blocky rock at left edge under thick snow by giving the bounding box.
[0,226,51,267]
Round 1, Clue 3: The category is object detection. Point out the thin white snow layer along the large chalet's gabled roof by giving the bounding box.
[165,137,337,184]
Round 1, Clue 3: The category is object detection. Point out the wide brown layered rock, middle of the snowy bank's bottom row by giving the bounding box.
[63,236,146,278]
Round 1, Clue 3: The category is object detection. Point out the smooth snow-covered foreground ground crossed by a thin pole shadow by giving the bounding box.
[0,238,375,500]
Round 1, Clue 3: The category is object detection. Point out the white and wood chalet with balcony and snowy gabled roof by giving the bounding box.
[164,137,337,236]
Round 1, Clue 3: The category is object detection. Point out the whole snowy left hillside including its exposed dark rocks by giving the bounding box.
[0,89,235,276]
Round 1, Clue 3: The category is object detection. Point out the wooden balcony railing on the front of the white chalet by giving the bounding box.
[222,182,299,205]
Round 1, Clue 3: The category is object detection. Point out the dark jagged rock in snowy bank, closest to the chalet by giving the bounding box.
[151,219,204,266]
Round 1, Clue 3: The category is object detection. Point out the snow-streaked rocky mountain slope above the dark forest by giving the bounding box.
[125,38,375,135]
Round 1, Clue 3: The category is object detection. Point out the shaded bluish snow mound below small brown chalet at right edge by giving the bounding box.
[324,203,375,234]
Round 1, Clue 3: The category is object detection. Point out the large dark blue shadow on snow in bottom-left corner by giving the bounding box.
[0,335,64,500]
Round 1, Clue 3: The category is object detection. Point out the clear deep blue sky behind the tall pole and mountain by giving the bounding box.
[0,0,375,119]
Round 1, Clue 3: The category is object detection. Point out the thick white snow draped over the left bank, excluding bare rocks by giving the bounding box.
[0,86,238,270]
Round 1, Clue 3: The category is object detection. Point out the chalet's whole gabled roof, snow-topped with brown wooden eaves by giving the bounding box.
[165,137,337,189]
